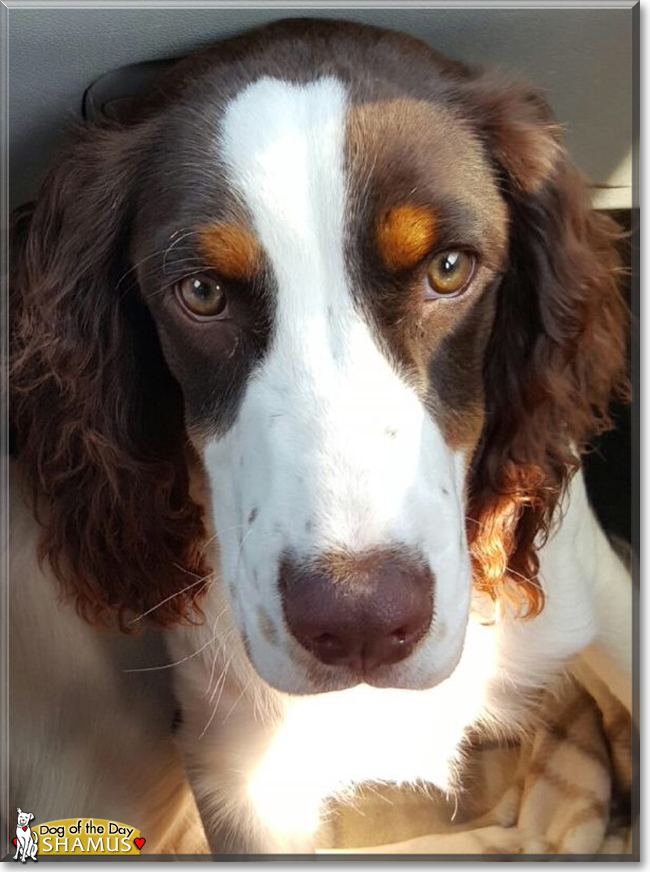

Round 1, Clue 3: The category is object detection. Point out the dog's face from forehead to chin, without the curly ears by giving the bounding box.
[135,74,507,692]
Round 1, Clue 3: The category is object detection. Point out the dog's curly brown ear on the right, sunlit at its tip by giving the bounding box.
[456,77,627,614]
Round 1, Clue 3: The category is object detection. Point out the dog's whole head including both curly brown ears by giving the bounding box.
[13,21,624,692]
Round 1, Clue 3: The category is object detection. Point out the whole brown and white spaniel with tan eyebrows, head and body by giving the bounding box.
[11,20,631,854]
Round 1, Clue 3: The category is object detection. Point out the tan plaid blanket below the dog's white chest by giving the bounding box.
[321,666,632,855]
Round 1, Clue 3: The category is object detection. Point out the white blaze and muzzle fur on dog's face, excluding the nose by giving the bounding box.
[204,79,471,693]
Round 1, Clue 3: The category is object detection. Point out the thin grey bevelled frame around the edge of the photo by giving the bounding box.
[0,0,645,864]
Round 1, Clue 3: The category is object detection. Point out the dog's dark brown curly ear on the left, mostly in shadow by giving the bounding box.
[11,122,208,625]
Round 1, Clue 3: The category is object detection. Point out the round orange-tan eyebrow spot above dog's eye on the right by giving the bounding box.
[377,204,436,272]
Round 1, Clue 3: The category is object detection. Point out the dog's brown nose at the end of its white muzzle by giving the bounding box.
[280,551,434,673]
